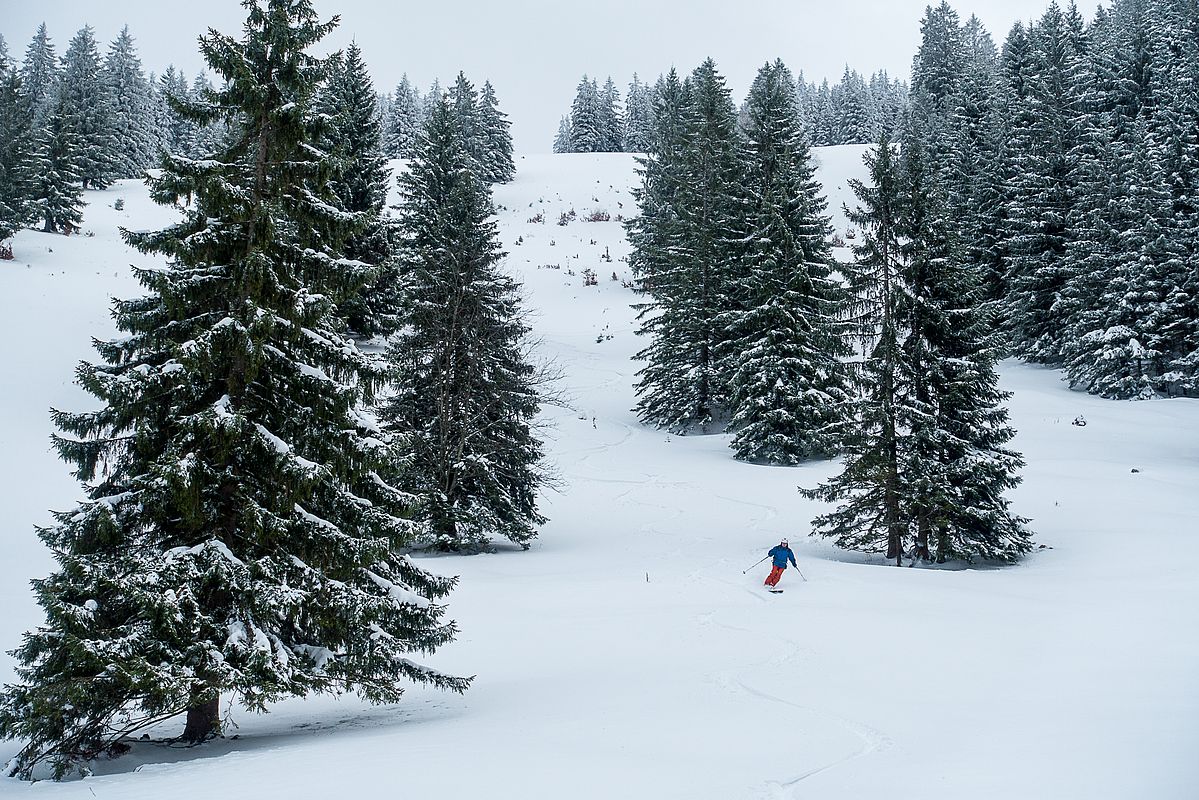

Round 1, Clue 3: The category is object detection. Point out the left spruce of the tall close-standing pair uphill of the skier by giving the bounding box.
[629,59,746,432]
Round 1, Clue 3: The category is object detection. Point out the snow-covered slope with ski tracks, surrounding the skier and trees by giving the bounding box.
[0,146,1199,800]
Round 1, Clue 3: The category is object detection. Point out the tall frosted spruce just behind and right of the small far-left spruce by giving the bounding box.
[59,25,115,188]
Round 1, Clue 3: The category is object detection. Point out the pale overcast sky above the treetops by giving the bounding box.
[0,0,1064,152]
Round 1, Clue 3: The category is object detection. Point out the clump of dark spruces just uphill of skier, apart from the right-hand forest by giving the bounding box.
[628,54,1030,564]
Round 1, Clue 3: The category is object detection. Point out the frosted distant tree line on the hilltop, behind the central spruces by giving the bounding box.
[554,67,908,152]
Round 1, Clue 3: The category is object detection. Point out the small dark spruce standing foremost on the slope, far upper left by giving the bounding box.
[29,92,84,234]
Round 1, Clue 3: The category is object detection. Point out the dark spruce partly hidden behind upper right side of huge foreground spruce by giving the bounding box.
[317,42,399,337]
